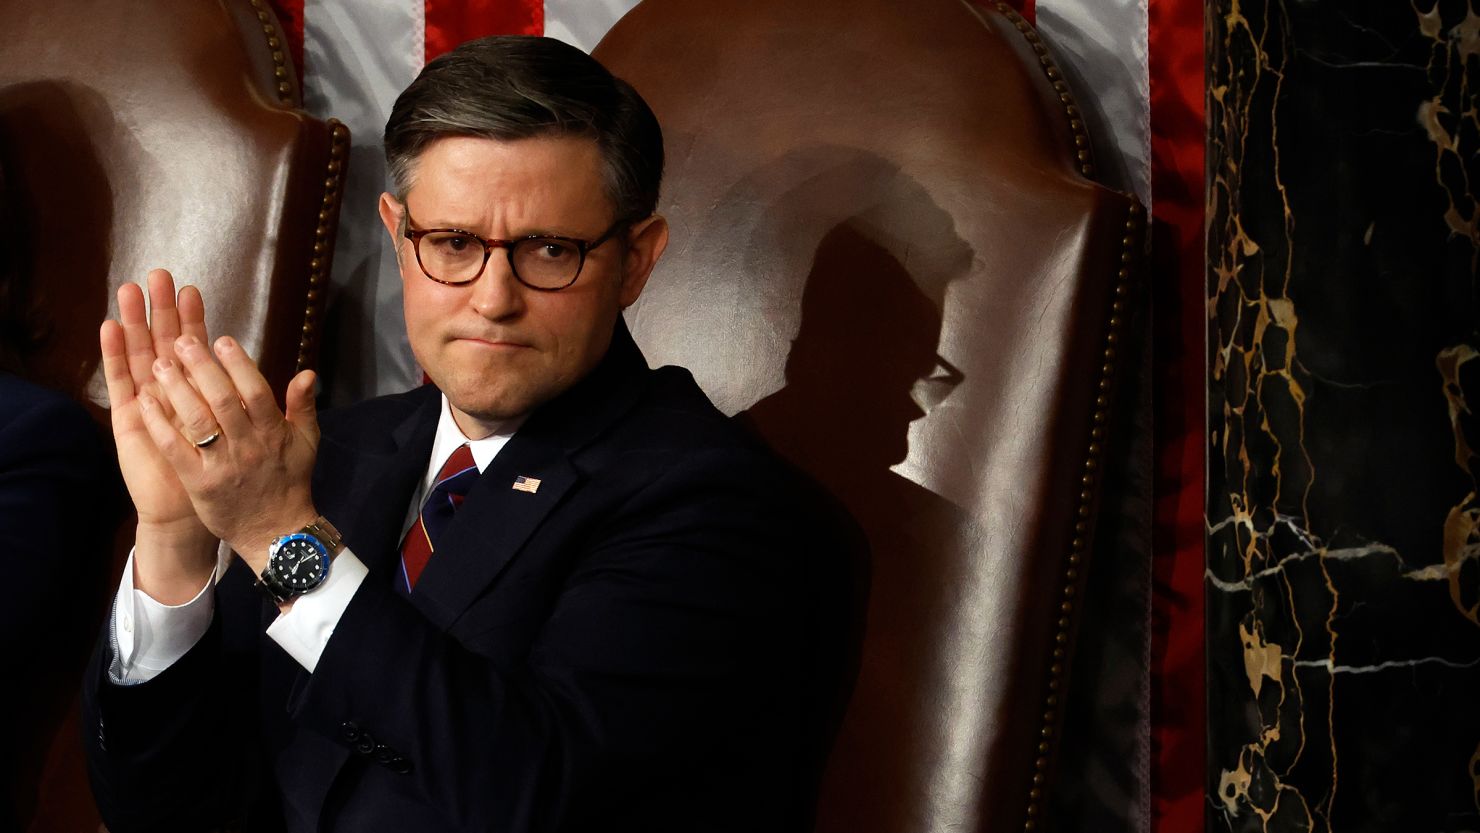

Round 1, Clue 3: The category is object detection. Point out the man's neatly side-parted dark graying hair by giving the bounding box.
[385,36,663,220]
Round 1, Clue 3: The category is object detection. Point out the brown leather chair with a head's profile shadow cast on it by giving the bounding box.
[595,0,1144,833]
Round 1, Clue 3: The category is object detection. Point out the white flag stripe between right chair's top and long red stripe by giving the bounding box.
[1037,0,1151,209]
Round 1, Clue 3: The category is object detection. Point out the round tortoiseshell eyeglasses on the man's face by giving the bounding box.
[404,212,626,291]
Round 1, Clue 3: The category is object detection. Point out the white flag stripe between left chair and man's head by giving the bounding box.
[303,0,425,404]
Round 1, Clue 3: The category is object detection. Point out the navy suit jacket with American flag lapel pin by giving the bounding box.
[84,324,860,833]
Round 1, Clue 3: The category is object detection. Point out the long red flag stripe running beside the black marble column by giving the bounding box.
[1147,0,1208,833]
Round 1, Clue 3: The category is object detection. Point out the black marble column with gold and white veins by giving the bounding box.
[1205,0,1480,833]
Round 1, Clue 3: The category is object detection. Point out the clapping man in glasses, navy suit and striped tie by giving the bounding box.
[84,38,848,833]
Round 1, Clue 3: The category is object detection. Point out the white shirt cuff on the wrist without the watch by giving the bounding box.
[108,546,231,685]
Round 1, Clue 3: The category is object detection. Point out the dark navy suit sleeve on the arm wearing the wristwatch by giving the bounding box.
[296,451,846,833]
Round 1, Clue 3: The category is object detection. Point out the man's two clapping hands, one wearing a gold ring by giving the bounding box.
[99,269,327,604]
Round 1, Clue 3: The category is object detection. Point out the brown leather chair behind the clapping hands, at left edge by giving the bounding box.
[0,0,349,830]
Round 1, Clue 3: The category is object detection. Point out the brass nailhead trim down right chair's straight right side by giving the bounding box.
[1018,195,1146,830]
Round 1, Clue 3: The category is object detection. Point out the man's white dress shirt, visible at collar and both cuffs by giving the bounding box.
[108,395,518,685]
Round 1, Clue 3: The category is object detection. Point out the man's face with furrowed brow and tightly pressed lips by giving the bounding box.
[380,138,667,438]
